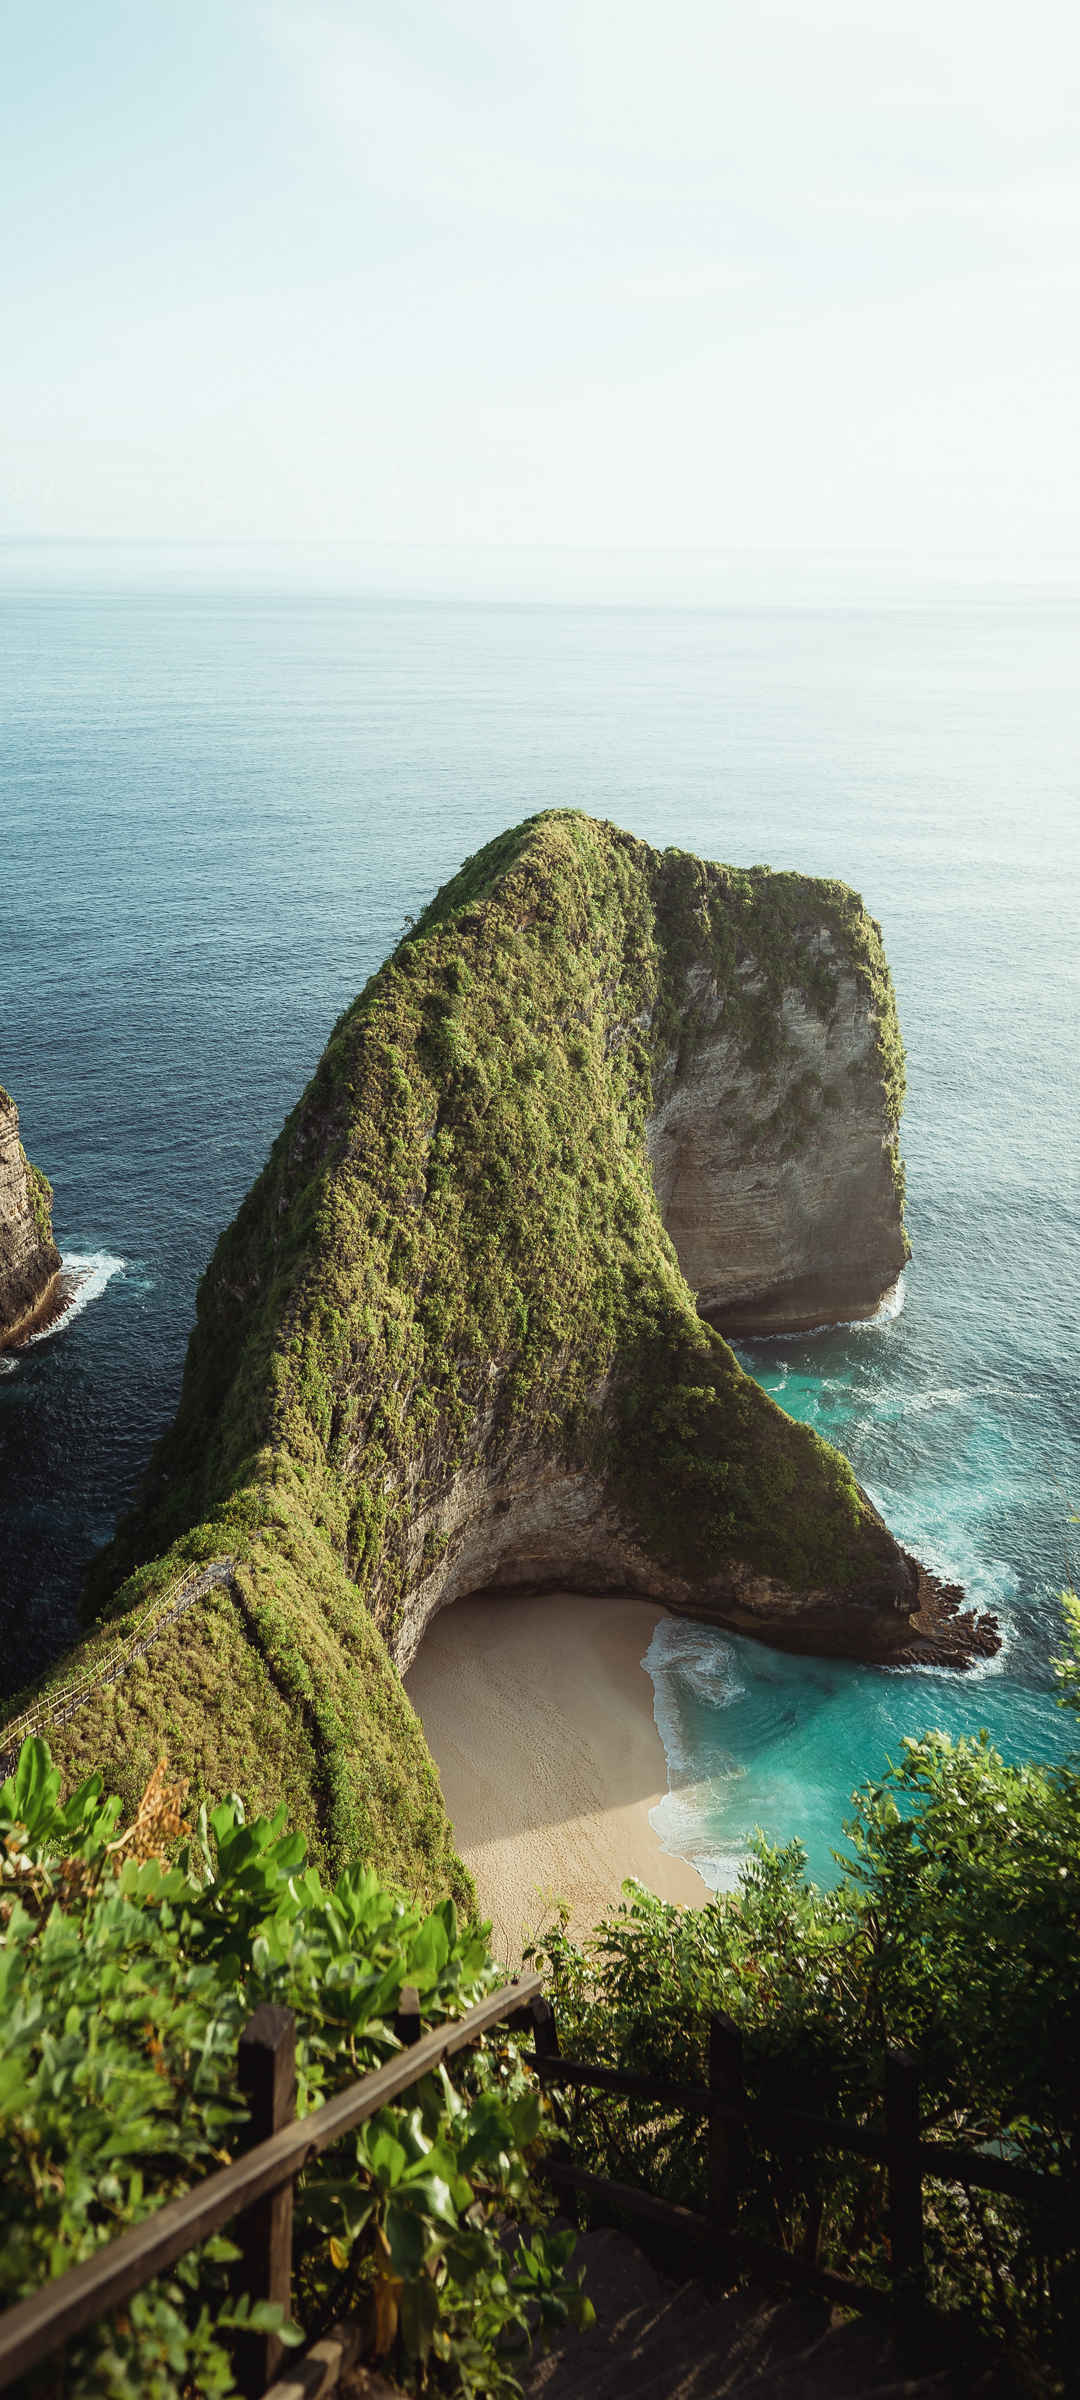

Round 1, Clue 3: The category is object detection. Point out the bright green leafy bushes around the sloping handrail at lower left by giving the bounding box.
[0,1740,586,2400]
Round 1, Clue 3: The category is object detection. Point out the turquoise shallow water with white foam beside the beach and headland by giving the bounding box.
[648,1274,1075,1889]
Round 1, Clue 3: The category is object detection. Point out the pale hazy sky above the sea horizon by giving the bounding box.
[0,0,1080,576]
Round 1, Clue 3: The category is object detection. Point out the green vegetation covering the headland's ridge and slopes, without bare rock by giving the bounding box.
[16,811,902,1889]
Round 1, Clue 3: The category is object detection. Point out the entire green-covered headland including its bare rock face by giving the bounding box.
[12,811,996,1882]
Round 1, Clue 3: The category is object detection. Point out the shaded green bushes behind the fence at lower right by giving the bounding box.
[530,1646,1080,2388]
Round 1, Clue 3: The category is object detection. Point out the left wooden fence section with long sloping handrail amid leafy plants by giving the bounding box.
[0,1975,547,2400]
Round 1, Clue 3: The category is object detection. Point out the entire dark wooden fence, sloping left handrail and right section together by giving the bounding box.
[0,1975,1065,2400]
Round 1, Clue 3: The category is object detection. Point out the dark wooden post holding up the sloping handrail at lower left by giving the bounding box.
[233,2002,295,2400]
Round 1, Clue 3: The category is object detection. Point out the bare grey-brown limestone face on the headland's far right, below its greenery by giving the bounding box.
[648,931,907,1332]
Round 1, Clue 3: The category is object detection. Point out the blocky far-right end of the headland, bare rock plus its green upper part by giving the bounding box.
[646,902,910,1334]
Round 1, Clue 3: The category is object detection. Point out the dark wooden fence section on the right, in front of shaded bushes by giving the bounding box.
[530,2009,1065,2321]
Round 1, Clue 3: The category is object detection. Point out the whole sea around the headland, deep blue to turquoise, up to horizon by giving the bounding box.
[0,569,1080,1877]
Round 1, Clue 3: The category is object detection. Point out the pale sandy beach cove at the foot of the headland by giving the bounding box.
[406,1594,710,1963]
